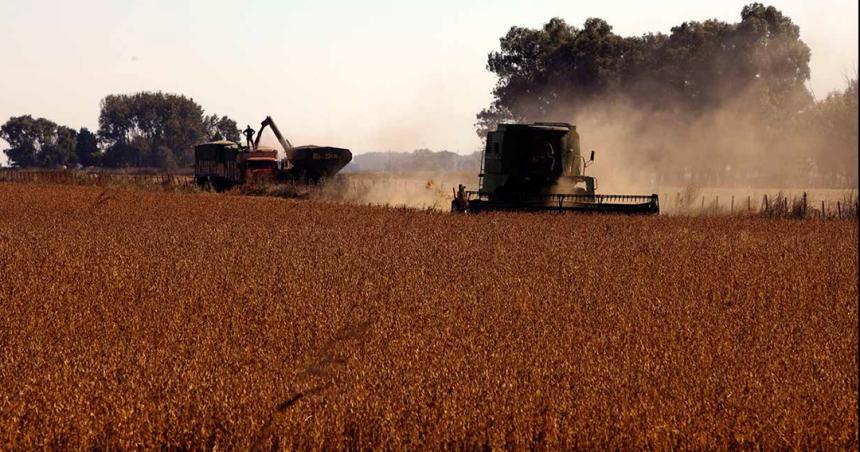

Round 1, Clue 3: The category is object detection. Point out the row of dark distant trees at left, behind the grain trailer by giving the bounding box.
[0,92,240,169]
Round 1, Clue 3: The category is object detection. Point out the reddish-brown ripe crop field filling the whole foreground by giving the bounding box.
[0,184,858,449]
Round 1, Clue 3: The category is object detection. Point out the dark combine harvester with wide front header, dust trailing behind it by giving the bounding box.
[451,122,660,214]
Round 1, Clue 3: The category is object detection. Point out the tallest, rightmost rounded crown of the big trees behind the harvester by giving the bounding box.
[643,3,812,114]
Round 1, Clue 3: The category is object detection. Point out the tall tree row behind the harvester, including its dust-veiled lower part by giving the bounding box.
[476,3,858,185]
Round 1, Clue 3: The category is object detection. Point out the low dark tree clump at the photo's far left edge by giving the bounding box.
[0,115,77,168]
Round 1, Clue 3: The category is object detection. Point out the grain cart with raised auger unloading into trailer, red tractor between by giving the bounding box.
[194,116,352,191]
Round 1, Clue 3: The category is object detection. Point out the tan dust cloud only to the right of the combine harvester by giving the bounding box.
[552,83,857,193]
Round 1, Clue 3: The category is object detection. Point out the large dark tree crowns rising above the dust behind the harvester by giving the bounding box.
[476,3,812,136]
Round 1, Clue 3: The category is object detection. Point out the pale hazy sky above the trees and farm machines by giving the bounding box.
[0,0,858,159]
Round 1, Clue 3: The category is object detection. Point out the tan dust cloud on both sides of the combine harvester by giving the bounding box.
[322,81,857,210]
